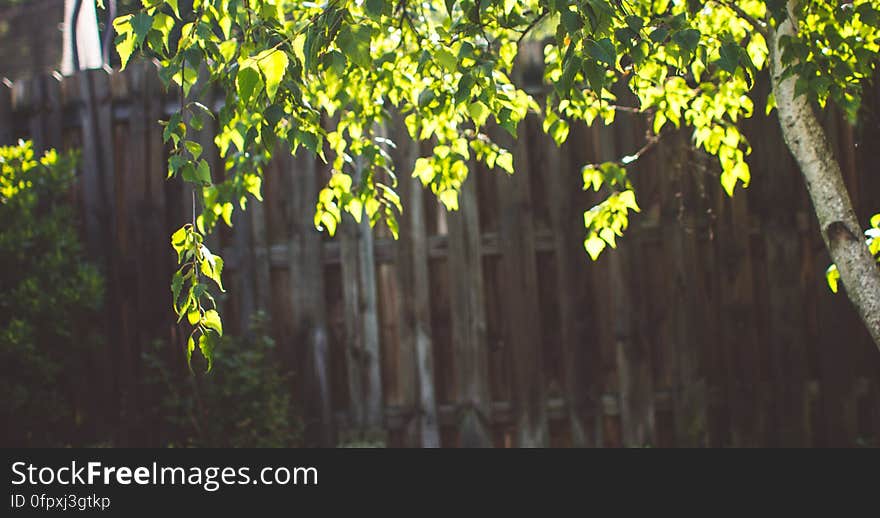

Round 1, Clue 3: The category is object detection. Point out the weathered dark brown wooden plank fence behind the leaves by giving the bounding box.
[0,64,880,447]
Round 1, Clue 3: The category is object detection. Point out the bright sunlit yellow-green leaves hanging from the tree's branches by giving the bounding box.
[114,0,880,355]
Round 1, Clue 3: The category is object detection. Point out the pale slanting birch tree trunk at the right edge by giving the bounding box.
[770,1,880,348]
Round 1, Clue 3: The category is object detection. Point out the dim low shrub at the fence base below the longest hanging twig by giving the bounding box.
[141,315,300,448]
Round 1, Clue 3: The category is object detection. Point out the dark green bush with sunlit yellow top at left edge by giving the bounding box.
[0,142,103,446]
